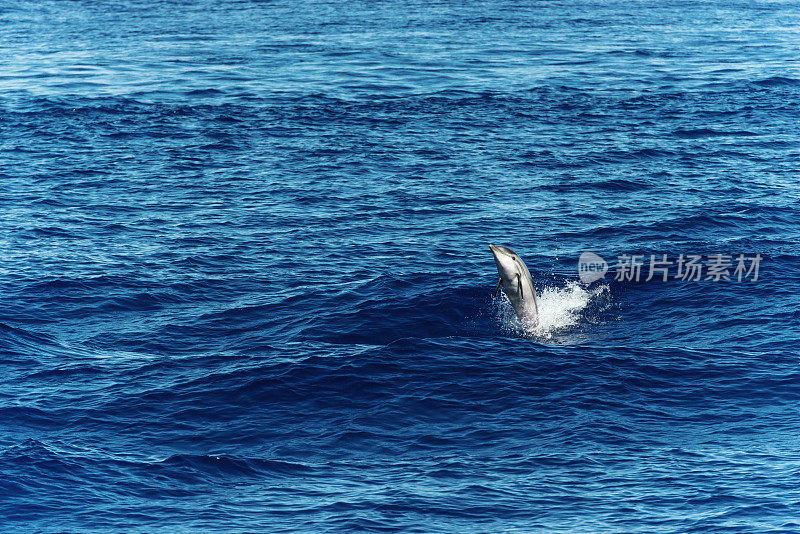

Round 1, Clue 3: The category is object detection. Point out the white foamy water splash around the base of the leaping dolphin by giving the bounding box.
[495,281,608,339]
